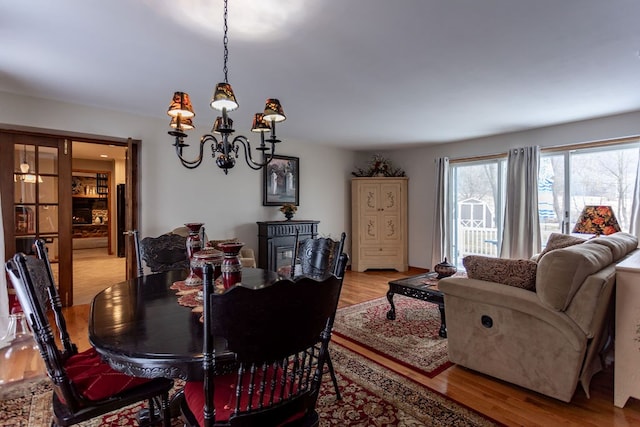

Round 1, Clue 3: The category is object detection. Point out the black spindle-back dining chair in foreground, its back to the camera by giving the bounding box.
[182,265,340,427]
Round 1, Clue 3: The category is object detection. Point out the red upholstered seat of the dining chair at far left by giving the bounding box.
[60,348,150,401]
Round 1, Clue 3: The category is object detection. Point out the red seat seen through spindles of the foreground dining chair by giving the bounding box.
[184,367,304,426]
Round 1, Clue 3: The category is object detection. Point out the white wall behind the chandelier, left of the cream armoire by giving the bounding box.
[0,92,355,256]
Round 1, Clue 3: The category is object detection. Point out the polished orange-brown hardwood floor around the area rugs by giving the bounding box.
[0,269,640,427]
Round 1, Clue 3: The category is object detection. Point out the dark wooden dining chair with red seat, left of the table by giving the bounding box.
[5,252,173,426]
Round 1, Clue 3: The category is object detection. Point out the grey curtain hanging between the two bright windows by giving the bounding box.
[500,146,541,259]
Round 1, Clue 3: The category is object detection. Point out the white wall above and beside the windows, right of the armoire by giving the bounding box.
[381,112,640,268]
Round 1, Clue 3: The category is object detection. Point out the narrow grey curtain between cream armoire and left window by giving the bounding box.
[431,157,451,268]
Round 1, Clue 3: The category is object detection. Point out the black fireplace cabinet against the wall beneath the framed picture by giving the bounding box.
[257,220,320,271]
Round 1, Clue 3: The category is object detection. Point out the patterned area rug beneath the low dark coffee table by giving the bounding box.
[333,295,451,377]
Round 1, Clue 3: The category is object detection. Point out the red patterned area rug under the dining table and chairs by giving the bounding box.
[0,343,499,427]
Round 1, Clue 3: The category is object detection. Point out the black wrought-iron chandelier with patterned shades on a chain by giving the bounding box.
[167,0,286,174]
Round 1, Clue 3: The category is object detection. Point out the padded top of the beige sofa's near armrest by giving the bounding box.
[438,277,585,351]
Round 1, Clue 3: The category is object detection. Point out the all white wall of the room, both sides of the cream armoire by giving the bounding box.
[5,92,640,268]
